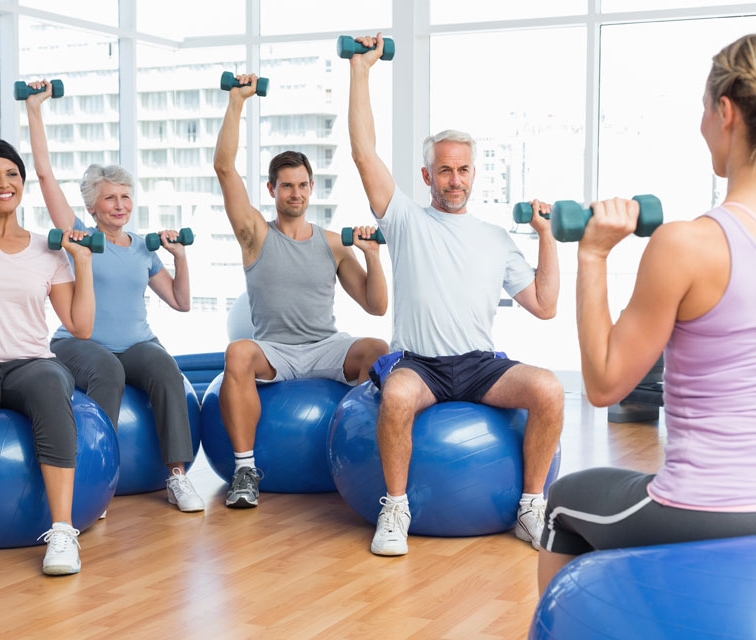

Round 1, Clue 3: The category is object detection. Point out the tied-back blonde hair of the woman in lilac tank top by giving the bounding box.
[706,34,756,162]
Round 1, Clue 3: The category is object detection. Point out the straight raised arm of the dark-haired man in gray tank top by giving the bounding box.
[213,75,267,267]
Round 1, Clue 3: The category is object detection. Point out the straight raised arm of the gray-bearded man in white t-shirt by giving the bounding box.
[349,33,395,218]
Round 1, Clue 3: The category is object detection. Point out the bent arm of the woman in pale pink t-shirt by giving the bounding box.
[50,231,95,340]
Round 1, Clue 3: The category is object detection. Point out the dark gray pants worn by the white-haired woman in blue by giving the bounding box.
[50,338,194,465]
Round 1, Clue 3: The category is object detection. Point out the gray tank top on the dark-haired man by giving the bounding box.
[244,221,336,344]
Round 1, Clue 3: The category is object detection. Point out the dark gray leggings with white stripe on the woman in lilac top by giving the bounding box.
[541,467,756,556]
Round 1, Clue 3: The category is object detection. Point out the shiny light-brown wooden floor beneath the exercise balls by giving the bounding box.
[0,394,666,640]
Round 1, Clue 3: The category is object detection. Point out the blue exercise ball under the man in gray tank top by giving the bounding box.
[201,374,351,493]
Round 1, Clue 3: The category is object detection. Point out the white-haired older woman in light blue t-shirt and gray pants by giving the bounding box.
[26,81,204,511]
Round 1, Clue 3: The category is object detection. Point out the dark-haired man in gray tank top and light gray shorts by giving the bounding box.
[214,75,388,508]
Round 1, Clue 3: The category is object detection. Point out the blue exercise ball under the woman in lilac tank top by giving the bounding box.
[528,536,756,640]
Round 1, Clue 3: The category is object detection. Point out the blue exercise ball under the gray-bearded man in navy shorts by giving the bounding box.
[328,381,561,536]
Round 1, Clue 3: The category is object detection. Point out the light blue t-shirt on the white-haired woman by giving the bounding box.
[52,218,163,353]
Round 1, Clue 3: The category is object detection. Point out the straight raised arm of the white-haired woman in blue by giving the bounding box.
[26,80,76,229]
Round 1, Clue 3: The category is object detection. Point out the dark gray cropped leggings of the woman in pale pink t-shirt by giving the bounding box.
[0,358,76,469]
